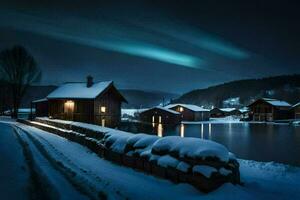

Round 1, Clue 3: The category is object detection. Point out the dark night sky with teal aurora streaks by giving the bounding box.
[0,0,300,93]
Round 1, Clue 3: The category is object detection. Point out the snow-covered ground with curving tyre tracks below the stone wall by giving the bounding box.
[0,119,300,200]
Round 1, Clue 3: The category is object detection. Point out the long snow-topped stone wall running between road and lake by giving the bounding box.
[26,118,240,192]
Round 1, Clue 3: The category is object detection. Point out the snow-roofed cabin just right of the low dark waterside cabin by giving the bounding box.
[165,104,209,121]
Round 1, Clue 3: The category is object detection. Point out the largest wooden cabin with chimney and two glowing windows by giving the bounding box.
[47,76,127,127]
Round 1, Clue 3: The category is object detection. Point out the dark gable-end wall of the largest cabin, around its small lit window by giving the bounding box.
[93,90,121,127]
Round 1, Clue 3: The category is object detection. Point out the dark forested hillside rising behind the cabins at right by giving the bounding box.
[173,74,300,107]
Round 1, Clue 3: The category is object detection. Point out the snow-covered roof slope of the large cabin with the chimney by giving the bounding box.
[47,81,112,99]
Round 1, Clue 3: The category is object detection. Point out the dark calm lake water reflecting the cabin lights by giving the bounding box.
[120,122,300,166]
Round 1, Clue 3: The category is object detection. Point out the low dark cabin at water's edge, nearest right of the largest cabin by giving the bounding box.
[139,106,181,124]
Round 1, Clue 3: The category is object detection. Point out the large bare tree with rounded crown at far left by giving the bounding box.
[0,46,41,118]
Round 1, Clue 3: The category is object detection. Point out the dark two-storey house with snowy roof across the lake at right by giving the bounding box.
[248,98,291,121]
